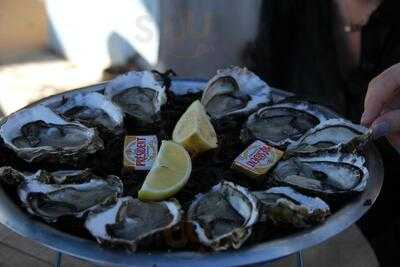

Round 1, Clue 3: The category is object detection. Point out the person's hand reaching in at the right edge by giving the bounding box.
[361,63,400,153]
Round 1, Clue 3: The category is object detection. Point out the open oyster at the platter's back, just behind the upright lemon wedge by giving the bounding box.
[201,67,272,119]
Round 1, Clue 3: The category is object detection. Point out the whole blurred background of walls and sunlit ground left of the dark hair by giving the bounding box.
[0,0,262,115]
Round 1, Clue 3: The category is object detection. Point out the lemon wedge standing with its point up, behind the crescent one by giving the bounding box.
[172,100,218,157]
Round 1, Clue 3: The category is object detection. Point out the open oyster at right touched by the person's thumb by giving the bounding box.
[288,119,369,152]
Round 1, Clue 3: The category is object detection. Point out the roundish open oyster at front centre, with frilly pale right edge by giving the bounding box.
[187,181,258,251]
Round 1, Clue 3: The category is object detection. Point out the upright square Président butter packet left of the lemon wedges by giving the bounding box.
[124,135,158,170]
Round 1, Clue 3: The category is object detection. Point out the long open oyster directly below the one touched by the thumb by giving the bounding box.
[272,151,369,194]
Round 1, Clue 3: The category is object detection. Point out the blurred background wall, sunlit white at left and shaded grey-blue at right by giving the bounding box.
[46,0,262,77]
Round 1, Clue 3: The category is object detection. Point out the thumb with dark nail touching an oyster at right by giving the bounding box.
[371,109,400,139]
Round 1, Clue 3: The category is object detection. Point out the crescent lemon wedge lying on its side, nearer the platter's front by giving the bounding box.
[138,141,192,201]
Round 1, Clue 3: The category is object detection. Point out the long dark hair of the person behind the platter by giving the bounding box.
[247,0,346,114]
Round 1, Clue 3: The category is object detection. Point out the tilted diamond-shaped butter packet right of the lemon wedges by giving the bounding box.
[232,140,284,177]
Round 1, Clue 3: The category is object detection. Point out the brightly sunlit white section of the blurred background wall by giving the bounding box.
[46,0,159,68]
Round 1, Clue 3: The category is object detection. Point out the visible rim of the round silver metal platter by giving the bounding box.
[0,79,383,267]
